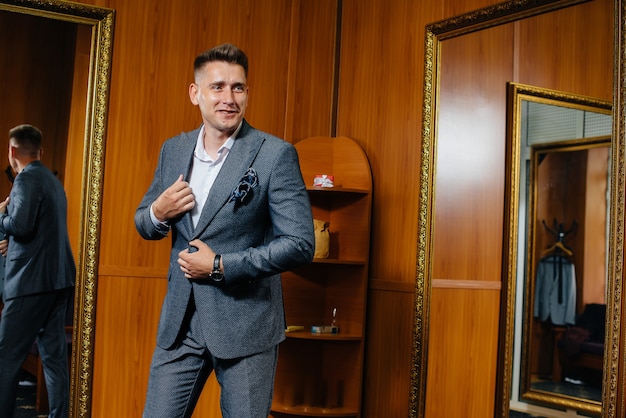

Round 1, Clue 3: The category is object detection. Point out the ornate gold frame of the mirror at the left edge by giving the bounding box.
[0,0,115,417]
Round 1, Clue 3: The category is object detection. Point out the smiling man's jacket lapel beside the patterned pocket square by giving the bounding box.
[193,121,263,238]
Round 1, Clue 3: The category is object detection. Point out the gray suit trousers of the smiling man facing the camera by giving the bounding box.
[143,302,278,418]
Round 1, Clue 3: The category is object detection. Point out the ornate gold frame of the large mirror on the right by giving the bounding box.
[409,0,626,418]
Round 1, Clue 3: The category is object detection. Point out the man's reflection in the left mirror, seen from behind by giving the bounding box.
[0,125,76,418]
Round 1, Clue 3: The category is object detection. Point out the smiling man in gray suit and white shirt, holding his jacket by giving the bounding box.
[135,44,314,418]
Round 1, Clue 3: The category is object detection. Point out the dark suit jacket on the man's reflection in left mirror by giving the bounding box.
[0,161,76,300]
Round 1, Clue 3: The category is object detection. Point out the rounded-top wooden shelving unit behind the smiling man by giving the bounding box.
[271,137,372,418]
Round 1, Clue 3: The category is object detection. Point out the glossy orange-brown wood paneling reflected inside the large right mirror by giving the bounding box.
[426,0,613,418]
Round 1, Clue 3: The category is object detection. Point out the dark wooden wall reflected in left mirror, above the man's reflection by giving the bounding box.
[0,11,83,255]
